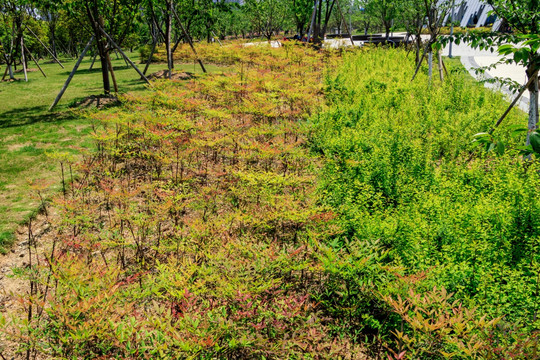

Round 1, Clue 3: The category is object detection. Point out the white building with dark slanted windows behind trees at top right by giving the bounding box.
[445,0,501,30]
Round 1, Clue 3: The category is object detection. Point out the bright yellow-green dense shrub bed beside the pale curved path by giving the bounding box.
[310,49,540,359]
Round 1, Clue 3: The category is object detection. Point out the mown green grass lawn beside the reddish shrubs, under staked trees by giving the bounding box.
[0,54,224,253]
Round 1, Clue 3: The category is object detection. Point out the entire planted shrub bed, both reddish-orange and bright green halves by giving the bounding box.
[5,45,538,359]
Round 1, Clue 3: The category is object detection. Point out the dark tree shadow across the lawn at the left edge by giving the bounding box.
[0,105,76,129]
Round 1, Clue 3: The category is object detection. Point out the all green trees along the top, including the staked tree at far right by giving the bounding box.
[0,0,539,130]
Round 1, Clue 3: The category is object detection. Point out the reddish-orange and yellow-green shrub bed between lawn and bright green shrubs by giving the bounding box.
[0,41,376,359]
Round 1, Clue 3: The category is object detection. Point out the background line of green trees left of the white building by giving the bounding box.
[0,0,442,60]
